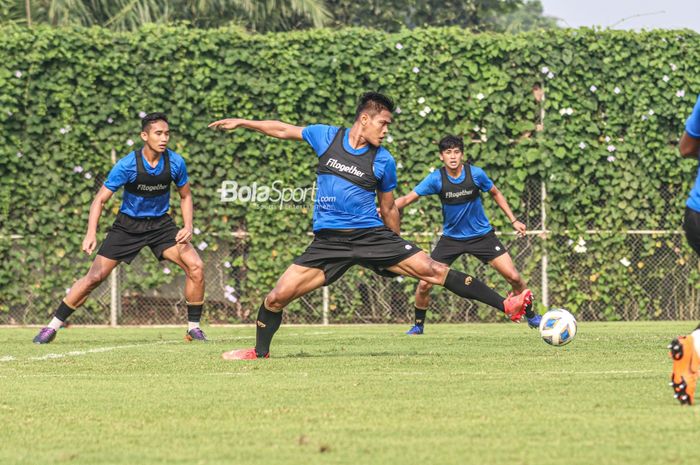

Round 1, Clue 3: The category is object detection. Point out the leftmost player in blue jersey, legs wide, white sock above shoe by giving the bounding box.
[34,113,206,344]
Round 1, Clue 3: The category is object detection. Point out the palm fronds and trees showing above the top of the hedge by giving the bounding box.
[0,0,556,32]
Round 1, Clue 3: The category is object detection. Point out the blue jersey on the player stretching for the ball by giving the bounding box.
[302,124,396,231]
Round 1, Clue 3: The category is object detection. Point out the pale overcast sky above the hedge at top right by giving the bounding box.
[541,0,700,32]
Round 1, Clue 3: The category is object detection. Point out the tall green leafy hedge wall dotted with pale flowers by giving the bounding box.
[0,26,700,318]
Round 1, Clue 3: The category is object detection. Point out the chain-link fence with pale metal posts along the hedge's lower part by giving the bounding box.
[0,178,700,326]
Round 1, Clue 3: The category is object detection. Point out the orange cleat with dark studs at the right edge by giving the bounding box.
[668,335,700,405]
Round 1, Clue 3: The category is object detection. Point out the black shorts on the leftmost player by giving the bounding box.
[97,212,179,263]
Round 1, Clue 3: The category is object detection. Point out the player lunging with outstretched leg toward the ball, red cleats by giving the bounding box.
[209,92,531,360]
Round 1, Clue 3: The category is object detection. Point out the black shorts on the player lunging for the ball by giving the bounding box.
[294,226,421,286]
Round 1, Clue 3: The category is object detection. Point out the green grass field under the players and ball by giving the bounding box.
[0,322,700,465]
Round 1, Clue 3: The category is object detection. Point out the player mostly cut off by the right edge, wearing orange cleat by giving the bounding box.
[668,96,700,405]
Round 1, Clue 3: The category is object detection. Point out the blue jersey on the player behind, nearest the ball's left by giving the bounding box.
[413,165,493,240]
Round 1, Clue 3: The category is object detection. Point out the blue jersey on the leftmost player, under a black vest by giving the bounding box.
[104,150,188,218]
